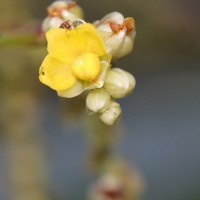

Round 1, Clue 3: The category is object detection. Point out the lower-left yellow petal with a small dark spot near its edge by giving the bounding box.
[39,55,77,90]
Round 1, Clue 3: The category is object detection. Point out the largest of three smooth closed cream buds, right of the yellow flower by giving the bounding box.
[104,68,136,98]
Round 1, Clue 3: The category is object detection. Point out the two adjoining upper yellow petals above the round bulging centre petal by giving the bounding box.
[46,23,106,64]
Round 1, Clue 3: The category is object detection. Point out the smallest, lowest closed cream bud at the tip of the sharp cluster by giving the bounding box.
[99,101,122,126]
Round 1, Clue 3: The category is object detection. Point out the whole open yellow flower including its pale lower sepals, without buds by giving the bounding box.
[39,23,111,97]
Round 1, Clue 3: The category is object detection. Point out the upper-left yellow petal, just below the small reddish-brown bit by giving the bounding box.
[46,28,86,64]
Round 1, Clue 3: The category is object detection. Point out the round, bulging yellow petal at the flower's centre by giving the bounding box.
[71,53,101,81]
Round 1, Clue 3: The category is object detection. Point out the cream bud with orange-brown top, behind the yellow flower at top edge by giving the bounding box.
[42,1,83,32]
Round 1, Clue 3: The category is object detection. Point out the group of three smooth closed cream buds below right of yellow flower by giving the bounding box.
[86,68,136,125]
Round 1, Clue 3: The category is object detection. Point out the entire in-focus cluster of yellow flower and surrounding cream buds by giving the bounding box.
[39,1,136,125]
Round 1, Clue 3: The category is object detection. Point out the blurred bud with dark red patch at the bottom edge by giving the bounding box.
[88,160,144,200]
